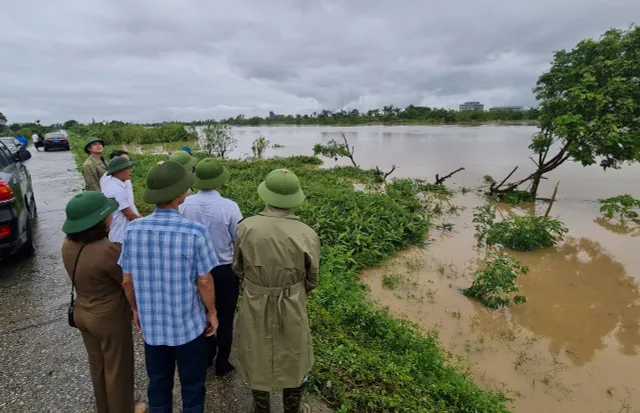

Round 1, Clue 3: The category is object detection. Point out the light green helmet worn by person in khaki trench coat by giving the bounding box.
[258,169,305,209]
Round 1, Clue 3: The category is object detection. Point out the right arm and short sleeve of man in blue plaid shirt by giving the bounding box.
[195,228,218,337]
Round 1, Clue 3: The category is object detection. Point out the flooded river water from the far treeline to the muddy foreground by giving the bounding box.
[132,126,640,413]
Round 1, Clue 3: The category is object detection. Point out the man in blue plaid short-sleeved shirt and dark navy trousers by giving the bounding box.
[118,161,218,413]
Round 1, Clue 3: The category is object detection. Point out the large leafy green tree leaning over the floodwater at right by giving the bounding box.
[491,26,640,197]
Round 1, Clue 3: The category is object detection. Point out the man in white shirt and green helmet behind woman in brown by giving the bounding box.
[100,156,140,244]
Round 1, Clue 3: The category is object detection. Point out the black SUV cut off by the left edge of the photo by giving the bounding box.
[0,141,36,260]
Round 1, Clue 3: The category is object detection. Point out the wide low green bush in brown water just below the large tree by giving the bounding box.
[487,216,568,251]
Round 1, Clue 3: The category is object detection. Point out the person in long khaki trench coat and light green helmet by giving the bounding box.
[231,169,320,413]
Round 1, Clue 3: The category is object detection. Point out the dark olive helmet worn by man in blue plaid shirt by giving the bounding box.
[142,161,196,205]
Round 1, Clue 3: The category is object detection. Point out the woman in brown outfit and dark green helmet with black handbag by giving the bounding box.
[62,191,147,413]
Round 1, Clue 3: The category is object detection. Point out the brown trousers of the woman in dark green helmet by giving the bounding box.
[74,306,134,413]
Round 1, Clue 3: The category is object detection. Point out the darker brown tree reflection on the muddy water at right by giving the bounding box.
[511,237,640,365]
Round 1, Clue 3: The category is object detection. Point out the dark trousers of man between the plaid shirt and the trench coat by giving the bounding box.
[207,264,240,374]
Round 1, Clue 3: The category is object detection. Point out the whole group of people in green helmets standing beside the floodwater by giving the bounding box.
[62,139,320,413]
